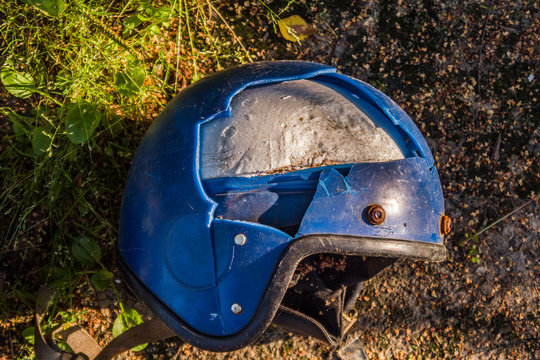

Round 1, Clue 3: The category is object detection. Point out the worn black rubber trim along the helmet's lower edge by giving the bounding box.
[118,235,446,352]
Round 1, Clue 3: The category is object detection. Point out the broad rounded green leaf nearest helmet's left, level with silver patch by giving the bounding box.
[66,102,101,144]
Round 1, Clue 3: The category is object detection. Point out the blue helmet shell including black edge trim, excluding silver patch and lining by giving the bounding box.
[118,61,444,351]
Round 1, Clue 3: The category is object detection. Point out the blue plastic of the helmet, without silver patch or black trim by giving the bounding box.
[119,62,443,336]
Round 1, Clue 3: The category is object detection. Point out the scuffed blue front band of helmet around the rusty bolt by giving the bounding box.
[298,158,444,243]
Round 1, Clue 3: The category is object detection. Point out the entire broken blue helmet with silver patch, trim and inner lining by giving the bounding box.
[118,61,450,351]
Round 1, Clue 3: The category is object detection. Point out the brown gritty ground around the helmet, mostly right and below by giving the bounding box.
[0,0,540,359]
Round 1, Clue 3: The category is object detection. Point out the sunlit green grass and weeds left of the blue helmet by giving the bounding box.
[0,0,258,358]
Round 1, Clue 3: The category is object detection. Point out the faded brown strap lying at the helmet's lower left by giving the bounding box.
[34,286,176,360]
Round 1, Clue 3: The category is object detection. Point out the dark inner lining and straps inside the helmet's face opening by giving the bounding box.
[273,254,395,347]
